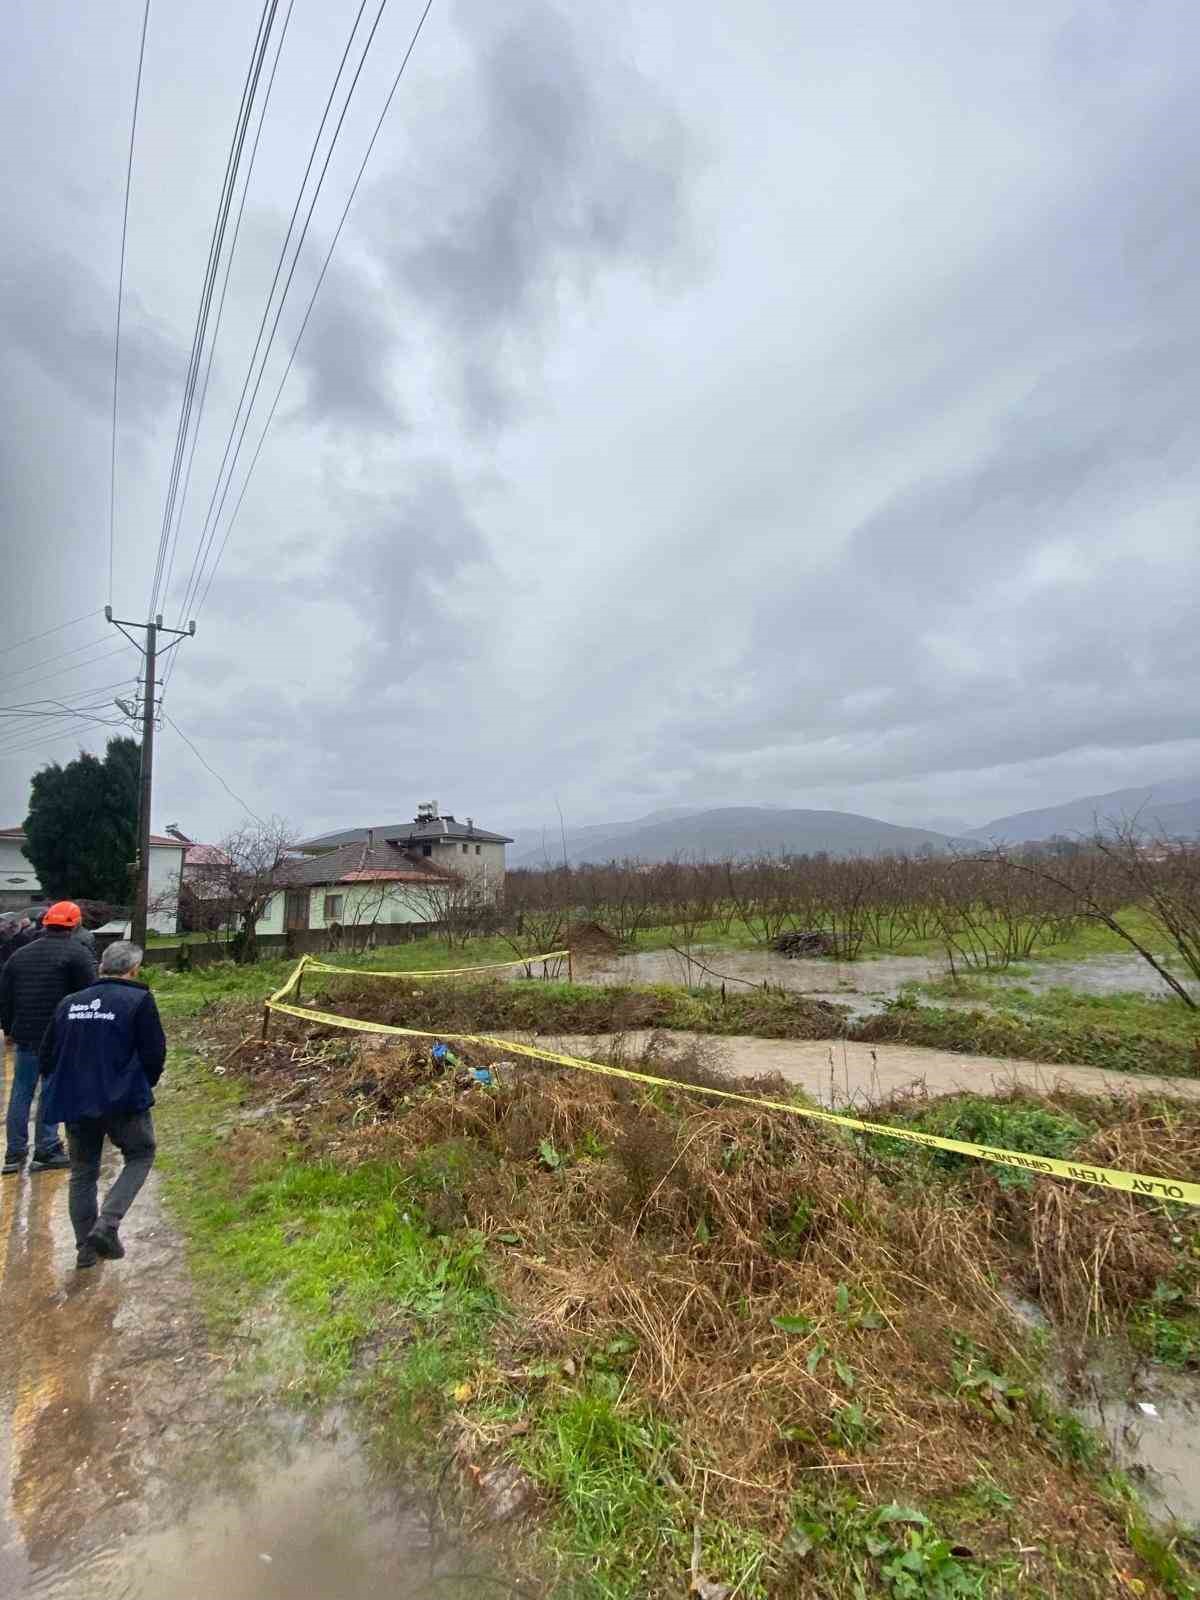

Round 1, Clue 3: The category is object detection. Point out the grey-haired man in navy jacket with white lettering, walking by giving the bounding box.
[38,939,166,1267]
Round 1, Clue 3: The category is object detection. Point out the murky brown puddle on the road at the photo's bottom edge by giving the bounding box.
[28,1442,507,1600]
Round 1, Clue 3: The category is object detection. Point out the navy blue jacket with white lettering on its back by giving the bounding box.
[38,978,166,1122]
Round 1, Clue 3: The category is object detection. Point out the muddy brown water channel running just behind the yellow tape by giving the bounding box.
[512,1032,1200,1106]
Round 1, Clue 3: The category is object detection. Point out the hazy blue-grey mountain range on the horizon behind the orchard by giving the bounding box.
[509,776,1200,867]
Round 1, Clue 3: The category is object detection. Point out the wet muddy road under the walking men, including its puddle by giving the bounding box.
[0,1056,504,1600]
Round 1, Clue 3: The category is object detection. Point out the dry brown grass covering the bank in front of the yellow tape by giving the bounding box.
[200,1016,1200,1595]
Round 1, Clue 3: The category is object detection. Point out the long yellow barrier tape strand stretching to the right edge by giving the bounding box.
[267,957,1200,1205]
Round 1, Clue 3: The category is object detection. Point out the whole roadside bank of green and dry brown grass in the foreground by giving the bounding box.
[165,985,1200,1600]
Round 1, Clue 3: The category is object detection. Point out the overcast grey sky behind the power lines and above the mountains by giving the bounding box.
[0,0,1200,837]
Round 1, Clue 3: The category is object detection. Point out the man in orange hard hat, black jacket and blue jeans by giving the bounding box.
[0,901,96,1174]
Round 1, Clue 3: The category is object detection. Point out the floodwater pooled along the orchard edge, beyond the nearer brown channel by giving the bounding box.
[574,946,1200,1018]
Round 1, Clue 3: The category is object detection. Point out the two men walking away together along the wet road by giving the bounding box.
[0,901,166,1267]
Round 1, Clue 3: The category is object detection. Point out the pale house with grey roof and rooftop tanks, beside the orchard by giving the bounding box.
[258,805,512,933]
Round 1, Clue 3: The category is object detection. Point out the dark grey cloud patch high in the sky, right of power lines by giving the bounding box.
[374,0,698,426]
